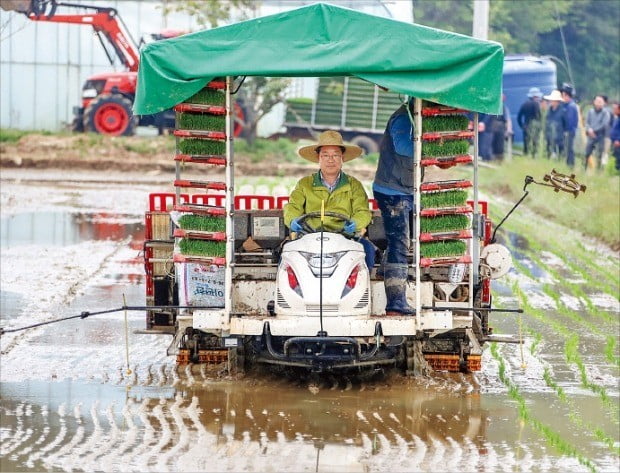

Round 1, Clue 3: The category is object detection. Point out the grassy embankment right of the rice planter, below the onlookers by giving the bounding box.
[472,157,620,250]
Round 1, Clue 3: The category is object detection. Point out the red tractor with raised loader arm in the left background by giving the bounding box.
[0,0,243,136]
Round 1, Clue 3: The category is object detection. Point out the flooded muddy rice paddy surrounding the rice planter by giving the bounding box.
[0,172,620,472]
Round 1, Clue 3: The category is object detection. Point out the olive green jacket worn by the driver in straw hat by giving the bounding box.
[284,171,372,232]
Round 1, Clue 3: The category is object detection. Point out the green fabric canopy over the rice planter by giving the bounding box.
[134,3,504,115]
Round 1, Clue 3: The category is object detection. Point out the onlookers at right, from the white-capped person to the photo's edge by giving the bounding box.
[517,83,620,170]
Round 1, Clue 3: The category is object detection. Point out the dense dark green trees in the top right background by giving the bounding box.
[414,0,620,100]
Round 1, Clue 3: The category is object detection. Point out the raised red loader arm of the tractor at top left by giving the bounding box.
[0,0,140,72]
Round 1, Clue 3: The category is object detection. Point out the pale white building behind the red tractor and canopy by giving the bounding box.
[0,0,412,131]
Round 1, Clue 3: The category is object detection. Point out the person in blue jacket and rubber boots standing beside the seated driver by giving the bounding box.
[372,99,415,316]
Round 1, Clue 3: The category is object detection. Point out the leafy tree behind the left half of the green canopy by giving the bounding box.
[164,0,291,146]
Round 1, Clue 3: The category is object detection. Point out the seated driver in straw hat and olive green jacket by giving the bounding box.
[284,130,376,270]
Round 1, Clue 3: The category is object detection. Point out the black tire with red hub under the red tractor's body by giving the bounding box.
[84,94,137,136]
